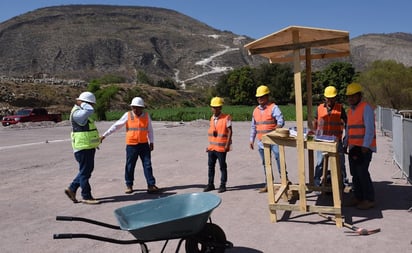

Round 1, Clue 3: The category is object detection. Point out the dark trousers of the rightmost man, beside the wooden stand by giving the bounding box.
[349,147,375,201]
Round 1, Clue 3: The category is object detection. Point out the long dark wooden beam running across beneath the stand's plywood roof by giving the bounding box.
[249,36,349,54]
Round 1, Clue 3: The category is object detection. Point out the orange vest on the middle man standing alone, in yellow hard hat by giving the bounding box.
[207,113,231,152]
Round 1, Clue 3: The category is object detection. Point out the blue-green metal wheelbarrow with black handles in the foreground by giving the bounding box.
[53,192,233,253]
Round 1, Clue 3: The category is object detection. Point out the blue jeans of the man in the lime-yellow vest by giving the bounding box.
[69,149,96,199]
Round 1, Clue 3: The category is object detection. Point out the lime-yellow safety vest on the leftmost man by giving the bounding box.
[70,107,100,150]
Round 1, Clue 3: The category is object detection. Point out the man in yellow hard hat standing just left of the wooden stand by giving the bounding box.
[249,85,285,193]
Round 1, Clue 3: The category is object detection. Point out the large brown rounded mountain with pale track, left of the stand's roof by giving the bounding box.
[0,5,266,88]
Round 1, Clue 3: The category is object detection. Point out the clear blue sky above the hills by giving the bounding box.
[0,0,412,39]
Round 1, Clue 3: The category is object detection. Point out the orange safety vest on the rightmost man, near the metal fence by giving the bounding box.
[348,101,376,147]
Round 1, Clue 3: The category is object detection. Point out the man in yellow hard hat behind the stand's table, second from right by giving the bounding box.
[313,86,348,189]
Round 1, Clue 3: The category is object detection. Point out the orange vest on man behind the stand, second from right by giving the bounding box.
[318,103,343,140]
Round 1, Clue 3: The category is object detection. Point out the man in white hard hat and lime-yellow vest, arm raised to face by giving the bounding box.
[64,91,100,204]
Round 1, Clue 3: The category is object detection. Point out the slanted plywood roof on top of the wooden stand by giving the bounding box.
[245,26,350,63]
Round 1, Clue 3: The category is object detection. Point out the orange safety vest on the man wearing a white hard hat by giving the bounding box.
[126,111,149,145]
